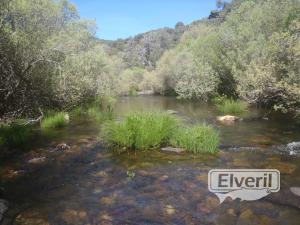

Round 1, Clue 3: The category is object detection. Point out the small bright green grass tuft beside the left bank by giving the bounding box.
[41,112,68,129]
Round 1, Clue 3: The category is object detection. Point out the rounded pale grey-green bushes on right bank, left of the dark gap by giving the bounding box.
[154,23,219,100]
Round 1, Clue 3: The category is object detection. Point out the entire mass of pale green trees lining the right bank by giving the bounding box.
[153,0,300,111]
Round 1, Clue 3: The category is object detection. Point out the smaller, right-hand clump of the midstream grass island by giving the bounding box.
[170,125,219,153]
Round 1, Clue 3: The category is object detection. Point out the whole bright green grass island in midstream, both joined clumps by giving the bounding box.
[103,112,219,153]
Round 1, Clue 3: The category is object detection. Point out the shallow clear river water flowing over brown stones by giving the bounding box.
[0,96,300,225]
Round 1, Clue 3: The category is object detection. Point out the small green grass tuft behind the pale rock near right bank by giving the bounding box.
[216,99,248,115]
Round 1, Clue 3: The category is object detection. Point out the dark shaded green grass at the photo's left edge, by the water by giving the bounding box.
[0,124,33,148]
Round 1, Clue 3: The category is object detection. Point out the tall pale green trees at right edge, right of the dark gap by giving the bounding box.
[219,0,300,109]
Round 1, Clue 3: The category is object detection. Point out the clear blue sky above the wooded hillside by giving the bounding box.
[70,0,216,40]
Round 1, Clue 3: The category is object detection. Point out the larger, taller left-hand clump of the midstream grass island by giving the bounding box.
[103,112,178,150]
